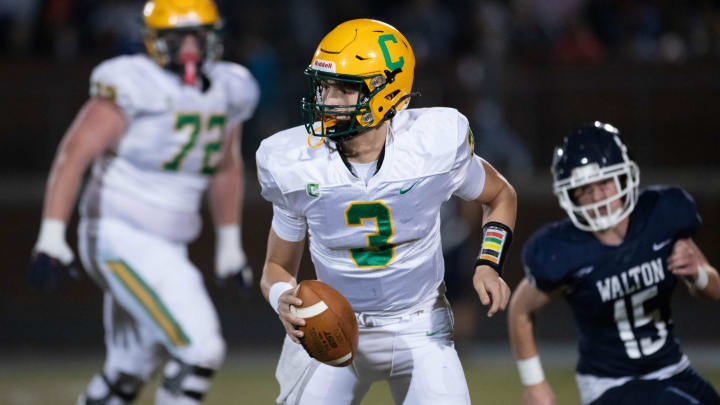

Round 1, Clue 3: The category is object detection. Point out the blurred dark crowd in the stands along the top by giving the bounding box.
[5,0,720,63]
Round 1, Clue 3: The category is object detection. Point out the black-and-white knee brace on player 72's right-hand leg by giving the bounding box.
[156,359,215,405]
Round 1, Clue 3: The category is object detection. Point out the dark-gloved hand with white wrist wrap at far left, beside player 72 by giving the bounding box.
[30,219,80,291]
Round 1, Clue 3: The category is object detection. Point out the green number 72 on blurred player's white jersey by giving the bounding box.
[163,114,225,175]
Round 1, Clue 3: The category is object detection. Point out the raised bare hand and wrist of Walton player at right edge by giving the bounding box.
[668,238,720,301]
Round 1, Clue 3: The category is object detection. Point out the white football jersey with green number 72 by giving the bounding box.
[81,55,259,242]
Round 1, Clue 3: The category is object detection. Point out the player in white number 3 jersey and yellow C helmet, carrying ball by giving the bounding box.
[257,19,516,405]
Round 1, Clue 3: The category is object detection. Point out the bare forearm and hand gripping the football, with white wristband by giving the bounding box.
[260,228,305,343]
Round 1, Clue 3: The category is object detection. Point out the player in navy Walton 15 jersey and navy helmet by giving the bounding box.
[508,122,720,405]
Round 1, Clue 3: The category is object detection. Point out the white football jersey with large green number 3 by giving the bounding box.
[257,108,485,311]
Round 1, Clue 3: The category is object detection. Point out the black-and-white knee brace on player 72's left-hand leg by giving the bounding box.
[78,373,143,405]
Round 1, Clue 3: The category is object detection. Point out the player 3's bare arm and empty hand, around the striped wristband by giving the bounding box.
[473,160,517,316]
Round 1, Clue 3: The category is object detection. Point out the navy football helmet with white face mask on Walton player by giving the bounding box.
[551,121,640,231]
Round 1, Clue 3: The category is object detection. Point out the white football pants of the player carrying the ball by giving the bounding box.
[276,295,470,405]
